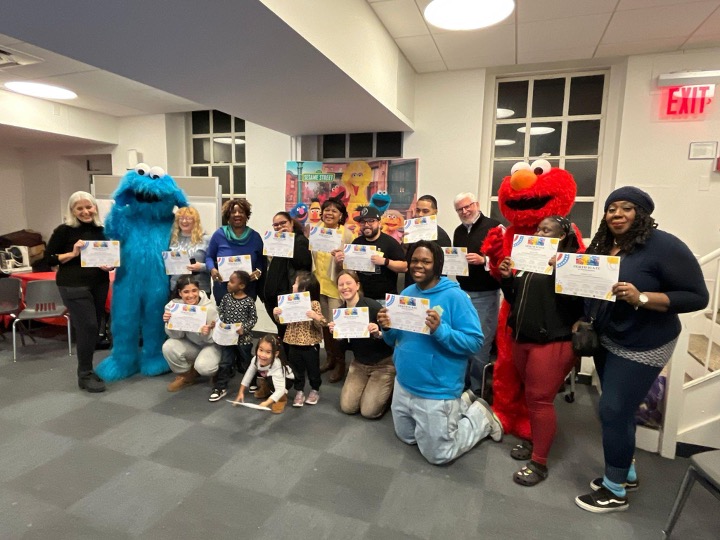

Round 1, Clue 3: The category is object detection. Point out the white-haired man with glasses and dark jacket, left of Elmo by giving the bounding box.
[453,193,500,390]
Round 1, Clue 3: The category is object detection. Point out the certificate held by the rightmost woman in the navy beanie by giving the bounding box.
[555,253,620,302]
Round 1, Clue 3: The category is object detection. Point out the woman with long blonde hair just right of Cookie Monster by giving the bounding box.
[169,206,210,296]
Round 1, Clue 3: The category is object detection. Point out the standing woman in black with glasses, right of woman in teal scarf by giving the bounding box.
[260,212,312,346]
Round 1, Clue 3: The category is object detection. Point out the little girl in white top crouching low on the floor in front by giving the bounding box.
[235,334,295,414]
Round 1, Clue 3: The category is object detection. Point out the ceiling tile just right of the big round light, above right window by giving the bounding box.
[518,13,611,52]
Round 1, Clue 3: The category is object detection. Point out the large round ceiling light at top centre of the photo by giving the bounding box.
[424,0,515,30]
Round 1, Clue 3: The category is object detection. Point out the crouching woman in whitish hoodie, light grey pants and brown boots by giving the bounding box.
[163,275,220,392]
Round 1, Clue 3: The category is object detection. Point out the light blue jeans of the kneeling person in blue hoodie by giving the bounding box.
[391,380,491,465]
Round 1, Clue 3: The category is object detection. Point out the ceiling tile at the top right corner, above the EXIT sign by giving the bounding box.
[602,0,717,44]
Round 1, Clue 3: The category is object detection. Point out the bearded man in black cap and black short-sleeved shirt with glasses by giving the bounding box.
[335,206,407,305]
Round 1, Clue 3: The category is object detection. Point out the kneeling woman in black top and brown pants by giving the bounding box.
[328,270,395,418]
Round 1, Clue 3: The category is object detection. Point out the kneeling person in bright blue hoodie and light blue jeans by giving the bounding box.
[377,241,503,465]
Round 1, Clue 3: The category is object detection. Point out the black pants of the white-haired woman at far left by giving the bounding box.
[58,283,110,377]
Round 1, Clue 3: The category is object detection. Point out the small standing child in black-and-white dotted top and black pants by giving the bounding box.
[208,270,262,401]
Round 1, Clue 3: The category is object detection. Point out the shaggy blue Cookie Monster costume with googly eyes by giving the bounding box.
[95,163,188,382]
